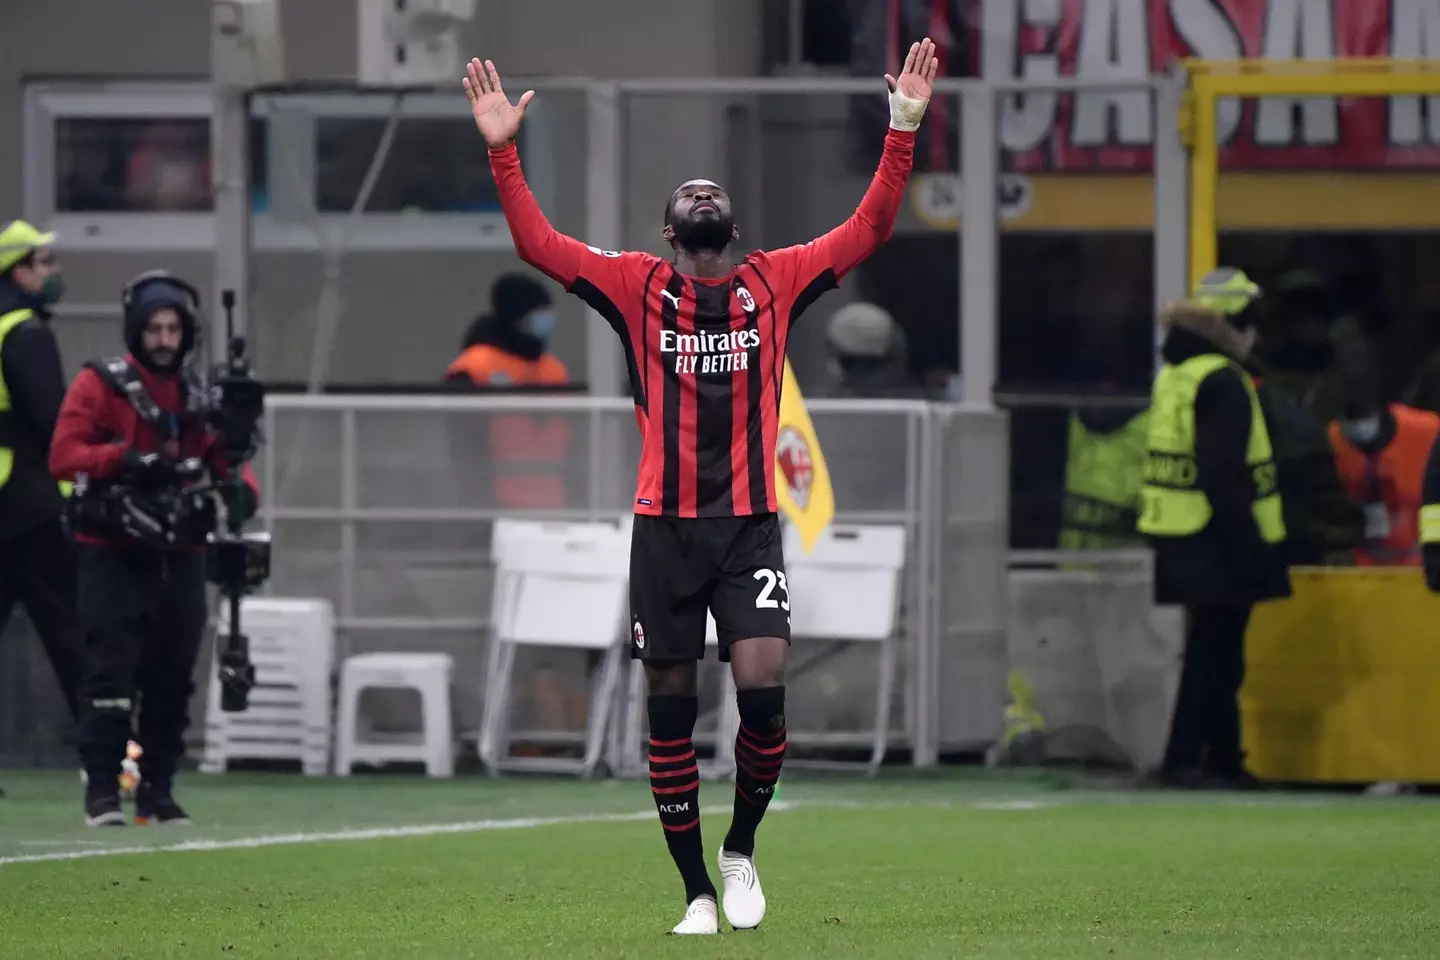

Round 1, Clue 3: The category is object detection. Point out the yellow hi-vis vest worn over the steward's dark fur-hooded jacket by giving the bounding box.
[1139,354,1284,544]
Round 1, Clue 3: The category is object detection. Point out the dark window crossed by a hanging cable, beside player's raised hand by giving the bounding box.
[315,117,501,213]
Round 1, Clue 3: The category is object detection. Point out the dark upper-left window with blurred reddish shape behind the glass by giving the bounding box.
[55,117,266,213]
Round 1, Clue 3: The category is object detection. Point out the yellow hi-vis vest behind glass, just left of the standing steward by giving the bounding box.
[1060,410,1149,550]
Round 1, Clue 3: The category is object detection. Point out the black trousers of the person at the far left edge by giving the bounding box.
[0,520,85,717]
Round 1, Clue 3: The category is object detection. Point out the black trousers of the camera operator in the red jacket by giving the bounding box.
[79,544,209,790]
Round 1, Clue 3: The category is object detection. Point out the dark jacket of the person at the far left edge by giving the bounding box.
[0,279,65,544]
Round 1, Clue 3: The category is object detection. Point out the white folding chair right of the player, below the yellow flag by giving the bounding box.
[785,525,906,776]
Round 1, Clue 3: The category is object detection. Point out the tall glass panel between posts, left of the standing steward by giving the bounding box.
[996,83,1155,550]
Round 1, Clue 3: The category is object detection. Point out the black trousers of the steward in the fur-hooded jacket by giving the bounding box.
[1165,604,1254,776]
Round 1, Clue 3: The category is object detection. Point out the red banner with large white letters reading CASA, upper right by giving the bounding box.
[984,0,1440,171]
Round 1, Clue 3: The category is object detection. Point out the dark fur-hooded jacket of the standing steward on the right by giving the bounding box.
[1152,304,1290,606]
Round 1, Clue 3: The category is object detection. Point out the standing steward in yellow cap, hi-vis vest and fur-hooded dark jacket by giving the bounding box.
[1139,268,1290,786]
